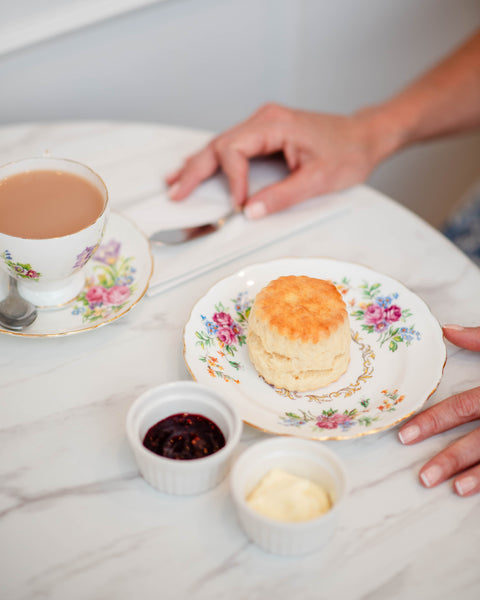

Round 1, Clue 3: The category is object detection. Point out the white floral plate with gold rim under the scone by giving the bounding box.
[184,258,446,440]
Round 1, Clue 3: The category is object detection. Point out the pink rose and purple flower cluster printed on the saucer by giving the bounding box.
[72,240,136,321]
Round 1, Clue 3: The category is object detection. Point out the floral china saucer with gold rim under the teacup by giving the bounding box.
[0,213,153,337]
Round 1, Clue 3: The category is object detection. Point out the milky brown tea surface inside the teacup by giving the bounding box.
[0,170,105,239]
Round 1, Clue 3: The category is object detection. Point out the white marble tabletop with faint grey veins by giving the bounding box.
[0,123,480,600]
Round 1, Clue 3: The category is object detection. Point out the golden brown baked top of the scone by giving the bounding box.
[255,275,348,344]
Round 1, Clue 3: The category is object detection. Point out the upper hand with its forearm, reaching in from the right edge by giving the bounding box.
[166,31,480,218]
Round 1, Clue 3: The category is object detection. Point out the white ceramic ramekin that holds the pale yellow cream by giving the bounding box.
[230,437,347,556]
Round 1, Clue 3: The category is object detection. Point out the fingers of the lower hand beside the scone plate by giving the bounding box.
[398,325,480,496]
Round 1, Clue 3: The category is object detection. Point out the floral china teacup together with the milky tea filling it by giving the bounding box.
[0,157,109,307]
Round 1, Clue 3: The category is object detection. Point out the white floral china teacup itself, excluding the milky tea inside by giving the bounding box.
[0,157,109,307]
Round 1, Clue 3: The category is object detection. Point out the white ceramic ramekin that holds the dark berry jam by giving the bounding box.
[127,381,242,496]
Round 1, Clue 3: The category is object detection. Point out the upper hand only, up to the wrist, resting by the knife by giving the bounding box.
[166,104,381,218]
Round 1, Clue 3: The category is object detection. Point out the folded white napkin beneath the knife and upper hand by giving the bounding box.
[122,159,348,296]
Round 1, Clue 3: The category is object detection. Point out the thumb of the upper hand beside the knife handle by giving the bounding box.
[245,168,325,219]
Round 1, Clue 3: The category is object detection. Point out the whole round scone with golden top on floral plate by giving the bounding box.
[247,275,351,392]
